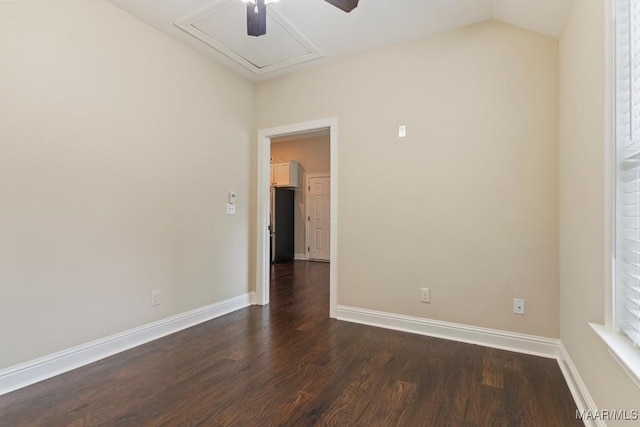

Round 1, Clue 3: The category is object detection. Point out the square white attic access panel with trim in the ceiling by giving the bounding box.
[174,0,323,76]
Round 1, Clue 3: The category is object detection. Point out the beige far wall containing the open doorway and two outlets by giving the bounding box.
[254,22,559,337]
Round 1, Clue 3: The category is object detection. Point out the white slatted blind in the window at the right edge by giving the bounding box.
[615,0,640,346]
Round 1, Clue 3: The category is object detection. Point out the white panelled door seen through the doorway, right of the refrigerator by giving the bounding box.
[307,175,331,261]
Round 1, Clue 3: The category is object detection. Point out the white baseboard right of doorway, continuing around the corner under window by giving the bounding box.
[337,305,605,427]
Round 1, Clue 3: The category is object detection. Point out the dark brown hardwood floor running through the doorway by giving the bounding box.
[0,261,582,427]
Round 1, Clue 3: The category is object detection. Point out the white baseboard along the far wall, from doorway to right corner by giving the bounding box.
[337,305,559,359]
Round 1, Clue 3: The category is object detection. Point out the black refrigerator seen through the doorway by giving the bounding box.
[271,187,296,263]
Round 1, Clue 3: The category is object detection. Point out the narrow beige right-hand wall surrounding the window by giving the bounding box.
[559,0,640,418]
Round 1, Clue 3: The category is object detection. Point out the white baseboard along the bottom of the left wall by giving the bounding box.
[0,294,255,395]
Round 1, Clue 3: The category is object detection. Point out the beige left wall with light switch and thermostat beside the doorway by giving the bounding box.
[0,0,254,369]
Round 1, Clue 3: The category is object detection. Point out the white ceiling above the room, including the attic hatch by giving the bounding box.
[110,0,572,80]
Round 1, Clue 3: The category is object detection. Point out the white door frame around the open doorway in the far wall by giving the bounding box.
[255,117,338,318]
